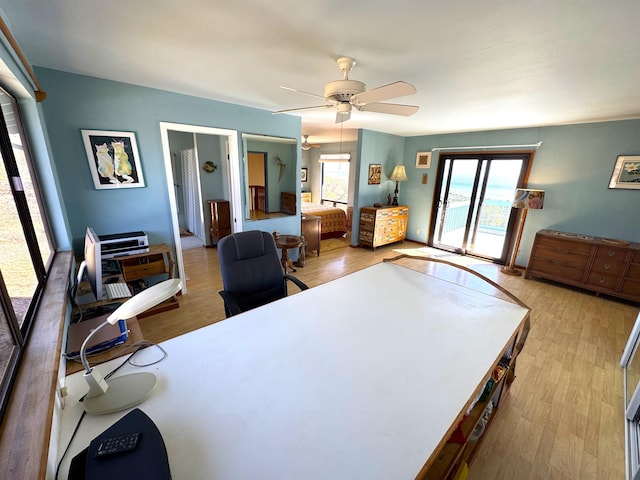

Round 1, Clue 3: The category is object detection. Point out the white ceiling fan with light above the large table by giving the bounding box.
[274,57,418,123]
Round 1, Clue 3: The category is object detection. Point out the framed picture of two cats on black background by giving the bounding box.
[81,130,145,190]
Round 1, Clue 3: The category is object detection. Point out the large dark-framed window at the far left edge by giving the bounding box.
[0,90,53,418]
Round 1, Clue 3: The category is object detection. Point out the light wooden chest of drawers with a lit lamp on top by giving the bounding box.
[358,206,409,249]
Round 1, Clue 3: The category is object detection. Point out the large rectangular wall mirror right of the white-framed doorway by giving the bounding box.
[242,133,299,220]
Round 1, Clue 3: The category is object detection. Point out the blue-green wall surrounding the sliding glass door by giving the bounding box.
[401,120,640,265]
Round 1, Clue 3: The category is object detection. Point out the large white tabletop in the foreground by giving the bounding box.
[59,263,528,480]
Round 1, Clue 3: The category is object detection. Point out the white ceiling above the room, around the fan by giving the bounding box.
[0,0,640,143]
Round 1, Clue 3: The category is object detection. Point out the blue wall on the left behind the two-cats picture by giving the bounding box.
[36,68,300,255]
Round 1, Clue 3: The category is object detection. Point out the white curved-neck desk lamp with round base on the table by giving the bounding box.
[80,278,182,414]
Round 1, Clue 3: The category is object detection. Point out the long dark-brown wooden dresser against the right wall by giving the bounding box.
[525,230,640,301]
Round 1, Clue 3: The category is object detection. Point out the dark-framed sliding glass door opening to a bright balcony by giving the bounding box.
[429,152,531,263]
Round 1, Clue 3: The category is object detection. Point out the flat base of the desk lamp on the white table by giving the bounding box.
[84,372,157,415]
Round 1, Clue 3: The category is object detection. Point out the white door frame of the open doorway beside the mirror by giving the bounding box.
[160,122,242,294]
